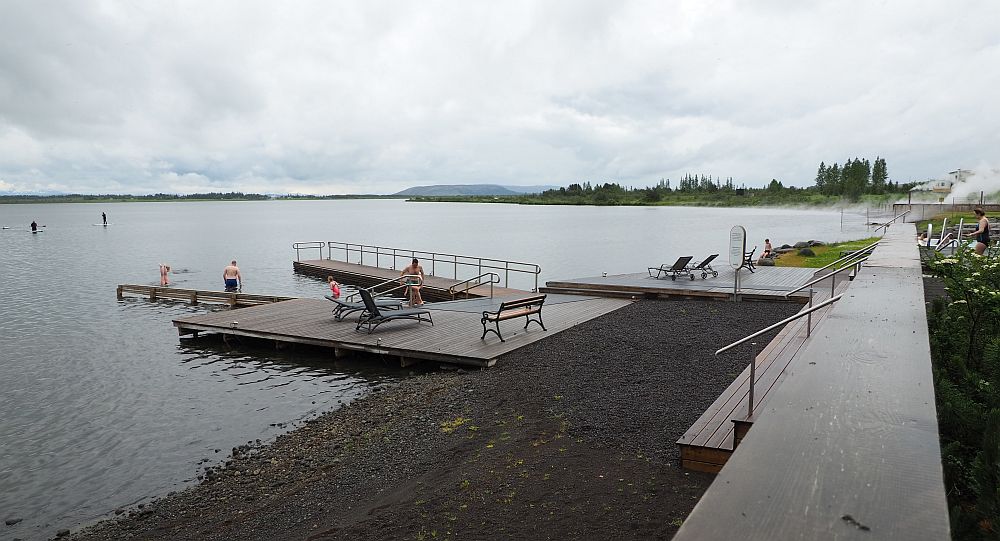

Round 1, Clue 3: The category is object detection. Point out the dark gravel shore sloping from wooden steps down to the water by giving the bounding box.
[71,301,799,540]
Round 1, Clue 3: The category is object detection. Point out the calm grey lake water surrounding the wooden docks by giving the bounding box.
[0,200,870,539]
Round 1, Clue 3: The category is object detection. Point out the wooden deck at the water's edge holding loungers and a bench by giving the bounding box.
[173,295,629,367]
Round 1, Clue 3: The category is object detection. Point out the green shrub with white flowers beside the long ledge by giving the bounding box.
[927,249,1000,539]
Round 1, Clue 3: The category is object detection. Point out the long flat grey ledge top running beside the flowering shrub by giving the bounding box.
[674,224,951,541]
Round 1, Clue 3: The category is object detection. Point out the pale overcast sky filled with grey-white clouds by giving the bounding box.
[0,0,1000,194]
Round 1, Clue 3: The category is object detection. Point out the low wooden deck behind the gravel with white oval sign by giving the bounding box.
[539,266,830,302]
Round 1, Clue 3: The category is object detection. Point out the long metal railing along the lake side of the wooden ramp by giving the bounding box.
[324,241,542,291]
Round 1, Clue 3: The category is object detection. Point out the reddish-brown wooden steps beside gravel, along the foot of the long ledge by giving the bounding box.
[677,280,850,473]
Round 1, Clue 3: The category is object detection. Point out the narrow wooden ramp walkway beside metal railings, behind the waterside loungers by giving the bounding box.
[292,259,528,302]
